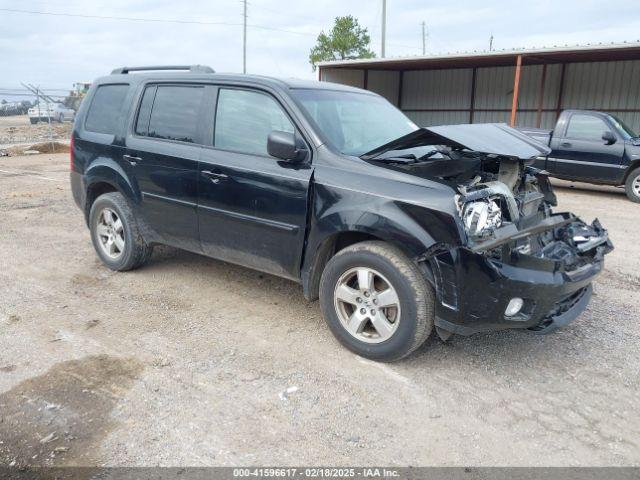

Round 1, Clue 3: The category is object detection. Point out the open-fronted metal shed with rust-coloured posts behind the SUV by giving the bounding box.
[318,42,640,130]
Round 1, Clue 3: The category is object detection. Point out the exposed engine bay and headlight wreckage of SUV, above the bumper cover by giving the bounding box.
[448,152,613,269]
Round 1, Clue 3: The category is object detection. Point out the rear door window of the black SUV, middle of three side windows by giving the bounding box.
[146,85,204,143]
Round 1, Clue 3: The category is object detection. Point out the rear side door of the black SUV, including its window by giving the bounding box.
[125,84,206,251]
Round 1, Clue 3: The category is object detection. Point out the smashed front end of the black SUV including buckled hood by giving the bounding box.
[367,125,613,339]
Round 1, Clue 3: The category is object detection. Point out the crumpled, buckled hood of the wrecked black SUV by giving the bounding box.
[360,123,551,160]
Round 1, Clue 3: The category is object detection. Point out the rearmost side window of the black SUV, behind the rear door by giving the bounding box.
[84,85,129,135]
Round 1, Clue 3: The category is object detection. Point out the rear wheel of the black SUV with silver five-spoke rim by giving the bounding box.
[89,192,153,272]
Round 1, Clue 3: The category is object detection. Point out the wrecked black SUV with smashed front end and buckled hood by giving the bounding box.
[71,66,612,361]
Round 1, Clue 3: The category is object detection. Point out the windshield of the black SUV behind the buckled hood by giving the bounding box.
[293,89,418,156]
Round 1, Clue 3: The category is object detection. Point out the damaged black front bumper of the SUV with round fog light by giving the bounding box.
[428,214,613,335]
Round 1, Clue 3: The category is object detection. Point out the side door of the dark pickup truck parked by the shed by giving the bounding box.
[550,112,624,183]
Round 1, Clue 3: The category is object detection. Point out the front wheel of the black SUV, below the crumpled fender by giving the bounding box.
[320,241,435,362]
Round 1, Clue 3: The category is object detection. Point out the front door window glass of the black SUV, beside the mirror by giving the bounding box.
[213,88,295,155]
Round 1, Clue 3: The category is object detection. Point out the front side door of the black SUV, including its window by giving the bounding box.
[198,87,312,279]
